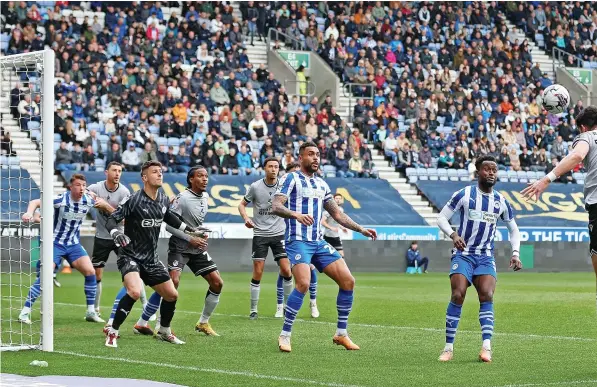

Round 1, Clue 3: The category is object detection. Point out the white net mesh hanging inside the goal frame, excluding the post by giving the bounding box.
[0,52,47,350]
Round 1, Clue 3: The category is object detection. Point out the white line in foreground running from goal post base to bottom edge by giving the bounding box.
[54,351,363,387]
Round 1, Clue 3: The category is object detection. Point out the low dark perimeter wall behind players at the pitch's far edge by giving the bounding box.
[0,236,592,273]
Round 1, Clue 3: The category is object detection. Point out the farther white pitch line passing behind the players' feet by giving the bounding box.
[47,302,597,342]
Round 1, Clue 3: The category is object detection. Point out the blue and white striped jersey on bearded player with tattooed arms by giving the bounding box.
[276,172,333,242]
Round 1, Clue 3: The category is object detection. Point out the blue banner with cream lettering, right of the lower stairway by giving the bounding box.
[417,181,589,229]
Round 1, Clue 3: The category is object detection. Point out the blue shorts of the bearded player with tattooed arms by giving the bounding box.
[286,240,342,273]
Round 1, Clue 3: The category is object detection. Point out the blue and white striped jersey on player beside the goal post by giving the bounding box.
[54,191,95,246]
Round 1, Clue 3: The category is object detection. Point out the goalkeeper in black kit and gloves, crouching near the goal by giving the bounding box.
[106,161,205,348]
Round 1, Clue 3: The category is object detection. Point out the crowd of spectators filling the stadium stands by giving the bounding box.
[2,2,595,183]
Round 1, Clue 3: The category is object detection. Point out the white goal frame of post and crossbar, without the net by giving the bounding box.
[0,49,55,352]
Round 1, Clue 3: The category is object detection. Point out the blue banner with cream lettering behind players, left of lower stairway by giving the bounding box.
[64,172,426,226]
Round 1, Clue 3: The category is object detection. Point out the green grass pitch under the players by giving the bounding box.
[0,273,597,387]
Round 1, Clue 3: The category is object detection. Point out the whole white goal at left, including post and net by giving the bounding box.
[0,50,54,351]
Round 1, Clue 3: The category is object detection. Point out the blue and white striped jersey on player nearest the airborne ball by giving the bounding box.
[446,185,514,256]
